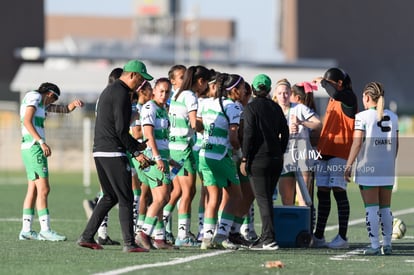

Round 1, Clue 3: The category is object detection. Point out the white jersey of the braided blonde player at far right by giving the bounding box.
[355,109,398,186]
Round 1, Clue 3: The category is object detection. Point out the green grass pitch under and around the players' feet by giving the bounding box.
[0,171,414,275]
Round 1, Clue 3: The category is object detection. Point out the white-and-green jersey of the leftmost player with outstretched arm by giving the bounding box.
[20,91,46,149]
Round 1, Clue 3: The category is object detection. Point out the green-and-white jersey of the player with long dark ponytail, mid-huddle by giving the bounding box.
[168,91,198,151]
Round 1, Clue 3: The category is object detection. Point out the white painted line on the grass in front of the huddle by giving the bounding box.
[95,250,234,275]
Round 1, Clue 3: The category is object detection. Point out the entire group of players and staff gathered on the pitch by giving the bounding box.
[19,60,398,255]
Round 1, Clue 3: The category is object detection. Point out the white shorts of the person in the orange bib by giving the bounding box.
[314,158,348,190]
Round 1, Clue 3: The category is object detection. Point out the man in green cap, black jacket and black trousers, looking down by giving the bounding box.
[78,60,153,252]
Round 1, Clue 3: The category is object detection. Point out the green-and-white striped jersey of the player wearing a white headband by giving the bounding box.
[200,98,240,160]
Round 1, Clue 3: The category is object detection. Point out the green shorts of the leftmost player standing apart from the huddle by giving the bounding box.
[21,144,49,181]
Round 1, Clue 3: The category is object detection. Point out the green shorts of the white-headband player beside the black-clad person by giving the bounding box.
[199,155,240,188]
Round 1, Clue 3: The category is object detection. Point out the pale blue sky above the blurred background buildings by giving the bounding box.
[45,0,280,61]
